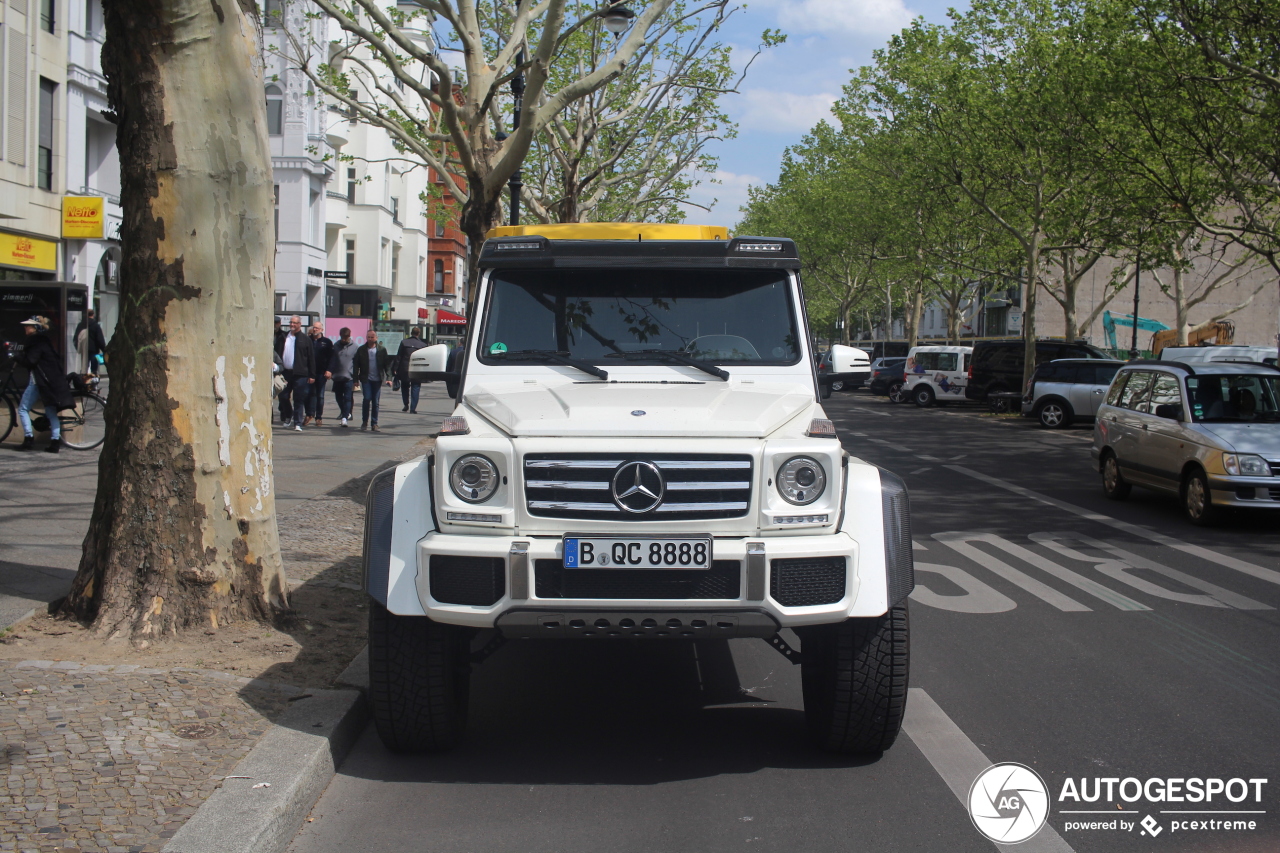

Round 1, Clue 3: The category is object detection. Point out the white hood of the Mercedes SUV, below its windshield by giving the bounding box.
[462,379,815,438]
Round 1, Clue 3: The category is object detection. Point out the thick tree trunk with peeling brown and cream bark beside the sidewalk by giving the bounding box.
[63,0,287,643]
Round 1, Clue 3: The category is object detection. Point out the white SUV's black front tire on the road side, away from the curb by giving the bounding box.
[796,602,910,753]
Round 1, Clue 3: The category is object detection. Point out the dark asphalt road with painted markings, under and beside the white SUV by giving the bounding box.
[291,392,1280,853]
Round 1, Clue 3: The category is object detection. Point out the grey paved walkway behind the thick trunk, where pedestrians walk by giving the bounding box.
[0,383,453,630]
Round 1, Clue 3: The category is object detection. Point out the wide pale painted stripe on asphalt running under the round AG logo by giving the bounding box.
[902,688,1075,853]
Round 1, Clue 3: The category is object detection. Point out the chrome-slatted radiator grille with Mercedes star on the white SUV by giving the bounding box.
[525,453,751,521]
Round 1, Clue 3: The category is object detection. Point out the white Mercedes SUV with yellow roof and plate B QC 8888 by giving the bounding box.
[364,224,914,752]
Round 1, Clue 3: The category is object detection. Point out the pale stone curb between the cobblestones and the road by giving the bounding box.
[163,676,367,853]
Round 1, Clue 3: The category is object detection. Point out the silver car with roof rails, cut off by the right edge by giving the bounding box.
[1091,361,1280,524]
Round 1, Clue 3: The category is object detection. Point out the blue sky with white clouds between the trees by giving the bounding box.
[686,0,965,225]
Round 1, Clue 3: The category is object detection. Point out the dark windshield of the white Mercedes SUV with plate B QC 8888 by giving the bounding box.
[480,269,800,365]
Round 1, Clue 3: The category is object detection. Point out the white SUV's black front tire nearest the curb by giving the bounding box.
[369,599,471,752]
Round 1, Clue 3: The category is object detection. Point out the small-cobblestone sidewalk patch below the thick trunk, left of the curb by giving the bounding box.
[0,661,294,853]
